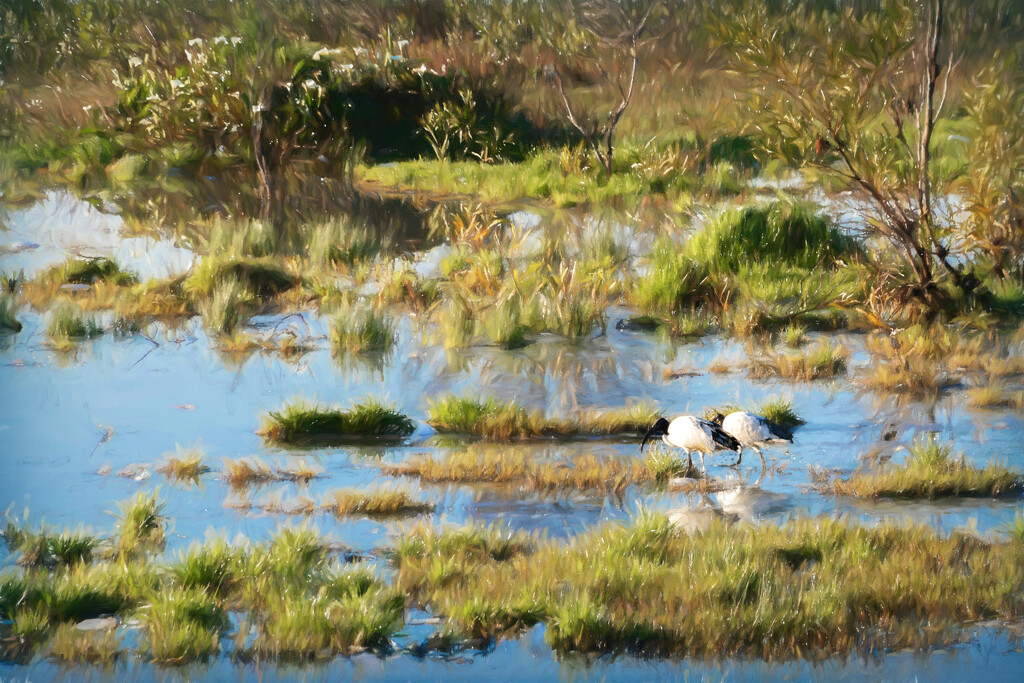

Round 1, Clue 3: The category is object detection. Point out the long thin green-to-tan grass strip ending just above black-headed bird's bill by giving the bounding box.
[427,394,662,439]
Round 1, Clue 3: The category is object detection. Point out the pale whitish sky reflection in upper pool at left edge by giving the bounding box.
[0,191,193,280]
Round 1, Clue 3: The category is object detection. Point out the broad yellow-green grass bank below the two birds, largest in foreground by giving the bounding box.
[391,513,1024,658]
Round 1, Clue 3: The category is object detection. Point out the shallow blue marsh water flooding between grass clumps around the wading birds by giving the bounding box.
[0,195,1024,680]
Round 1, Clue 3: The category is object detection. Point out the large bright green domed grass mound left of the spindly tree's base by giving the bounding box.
[684,201,859,272]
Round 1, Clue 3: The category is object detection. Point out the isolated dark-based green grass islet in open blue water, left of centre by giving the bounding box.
[259,398,416,443]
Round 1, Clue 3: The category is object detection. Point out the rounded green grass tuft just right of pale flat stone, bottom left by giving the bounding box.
[138,589,227,665]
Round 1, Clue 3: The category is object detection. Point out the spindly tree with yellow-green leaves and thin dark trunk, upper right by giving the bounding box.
[721,0,979,307]
